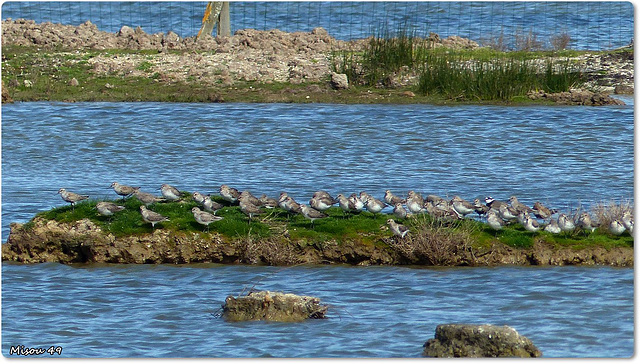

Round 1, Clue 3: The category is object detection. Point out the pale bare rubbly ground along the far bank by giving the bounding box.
[2,19,634,105]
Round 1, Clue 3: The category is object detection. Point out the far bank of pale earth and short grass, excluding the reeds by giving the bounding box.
[2,19,633,105]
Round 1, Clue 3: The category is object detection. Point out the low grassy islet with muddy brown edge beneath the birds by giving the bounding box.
[2,192,633,267]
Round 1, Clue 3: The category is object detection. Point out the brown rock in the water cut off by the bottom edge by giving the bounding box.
[422,324,542,358]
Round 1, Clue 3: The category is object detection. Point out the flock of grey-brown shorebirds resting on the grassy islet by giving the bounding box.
[58,182,633,238]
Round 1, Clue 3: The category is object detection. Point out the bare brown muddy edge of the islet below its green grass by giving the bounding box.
[2,217,634,267]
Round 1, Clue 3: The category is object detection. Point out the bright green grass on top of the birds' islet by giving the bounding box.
[25,194,633,253]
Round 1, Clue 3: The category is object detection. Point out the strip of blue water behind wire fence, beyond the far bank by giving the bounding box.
[2,1,634,50]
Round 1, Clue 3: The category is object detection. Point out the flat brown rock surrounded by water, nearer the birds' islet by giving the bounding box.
[222,291,329,322]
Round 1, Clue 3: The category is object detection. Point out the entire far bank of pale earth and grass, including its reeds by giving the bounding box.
[2,19,634,106]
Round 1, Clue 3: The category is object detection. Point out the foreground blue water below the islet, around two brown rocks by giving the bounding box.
[2,264,634,358]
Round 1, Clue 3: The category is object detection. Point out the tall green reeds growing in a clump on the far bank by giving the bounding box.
[333,30,583,101]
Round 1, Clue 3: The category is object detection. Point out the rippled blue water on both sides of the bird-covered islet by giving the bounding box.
[2,99,634,357]
